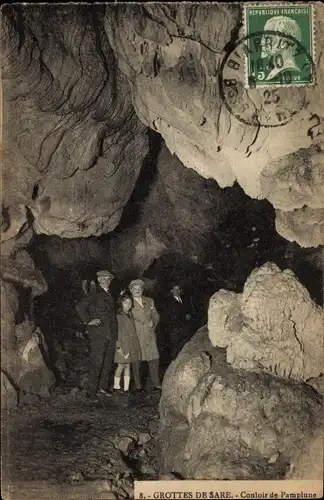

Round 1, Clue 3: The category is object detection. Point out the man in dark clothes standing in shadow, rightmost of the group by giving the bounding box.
[164,285,192,360]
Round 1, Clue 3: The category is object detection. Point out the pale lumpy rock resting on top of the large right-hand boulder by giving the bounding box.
[208,263,324,380]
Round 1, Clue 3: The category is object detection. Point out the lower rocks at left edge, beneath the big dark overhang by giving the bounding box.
[1,249,55,395]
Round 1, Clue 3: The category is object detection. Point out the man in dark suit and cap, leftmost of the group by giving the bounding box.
[76,271,118,395]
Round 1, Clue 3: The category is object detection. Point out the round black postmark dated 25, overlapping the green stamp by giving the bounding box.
[219,30,314,127]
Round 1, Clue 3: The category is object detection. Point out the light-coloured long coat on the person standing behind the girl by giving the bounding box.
[132,297,160,361]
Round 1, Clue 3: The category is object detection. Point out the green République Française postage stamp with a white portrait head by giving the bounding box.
[244,3,315,87]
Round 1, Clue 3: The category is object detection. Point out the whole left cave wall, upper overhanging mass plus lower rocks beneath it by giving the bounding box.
[1,5,148,394]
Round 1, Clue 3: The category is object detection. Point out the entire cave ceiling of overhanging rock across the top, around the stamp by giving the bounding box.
[1,3,324,248]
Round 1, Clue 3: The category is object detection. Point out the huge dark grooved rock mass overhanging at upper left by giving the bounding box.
[2,5,147,237]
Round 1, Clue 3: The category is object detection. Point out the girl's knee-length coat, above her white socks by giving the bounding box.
[115,312,141,363]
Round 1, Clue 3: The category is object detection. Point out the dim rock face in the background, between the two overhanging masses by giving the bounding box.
[109,143,251,273]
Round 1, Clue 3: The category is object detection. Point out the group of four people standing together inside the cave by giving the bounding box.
[76,270,194,396]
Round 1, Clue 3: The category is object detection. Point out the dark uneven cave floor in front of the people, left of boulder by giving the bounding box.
[1,391,159,500]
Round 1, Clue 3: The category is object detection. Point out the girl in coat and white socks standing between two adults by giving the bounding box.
[114,294,141,392]
